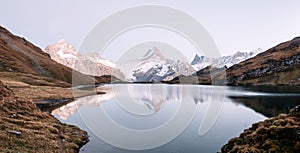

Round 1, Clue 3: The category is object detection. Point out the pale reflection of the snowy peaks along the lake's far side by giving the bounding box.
[52,84,218,120]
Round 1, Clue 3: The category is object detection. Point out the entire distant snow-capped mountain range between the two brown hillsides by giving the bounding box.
[44,39,262,82]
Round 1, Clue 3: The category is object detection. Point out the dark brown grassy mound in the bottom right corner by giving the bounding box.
[221,106,300,153]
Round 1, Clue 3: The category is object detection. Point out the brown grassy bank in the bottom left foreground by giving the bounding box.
[0,81,88,152]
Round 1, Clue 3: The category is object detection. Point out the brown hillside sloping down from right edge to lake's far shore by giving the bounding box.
[166,37,300,85]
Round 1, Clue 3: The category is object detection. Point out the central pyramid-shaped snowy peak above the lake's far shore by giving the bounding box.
[125,47,195,82]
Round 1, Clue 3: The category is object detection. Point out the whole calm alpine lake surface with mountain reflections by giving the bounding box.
[52,84,300,153]
